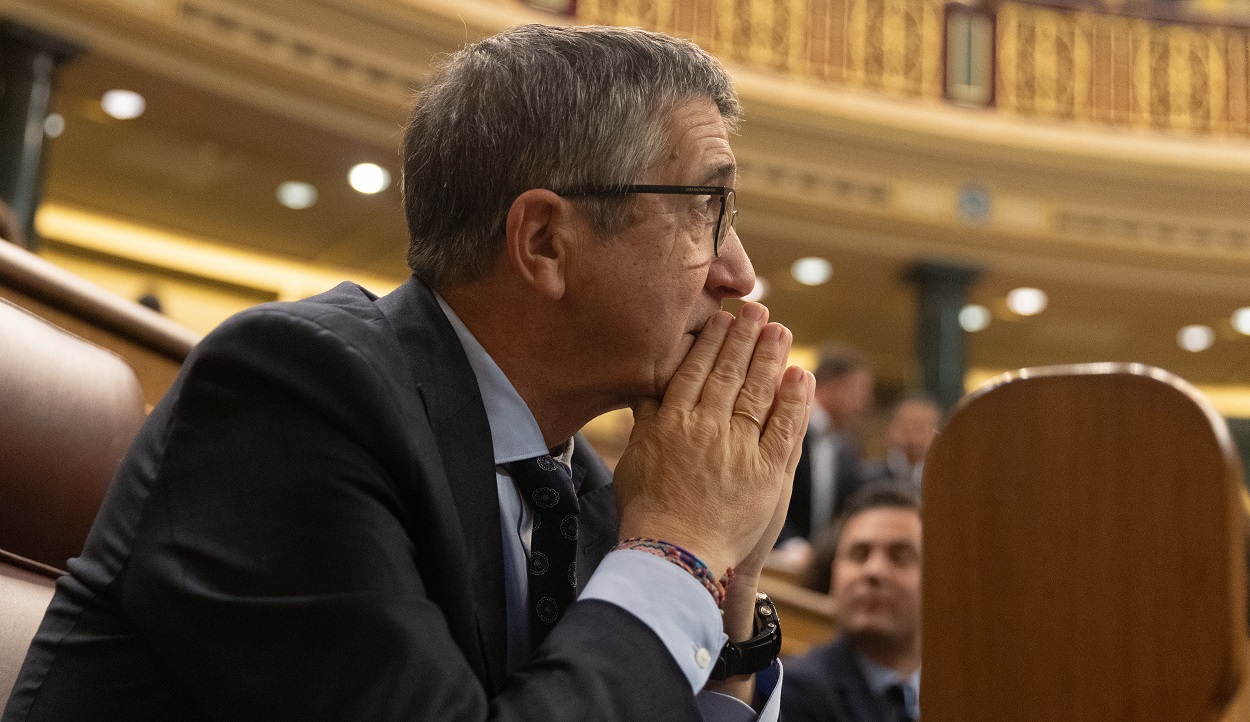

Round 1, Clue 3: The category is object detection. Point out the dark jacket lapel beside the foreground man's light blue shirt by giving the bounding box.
[378,279,508,692]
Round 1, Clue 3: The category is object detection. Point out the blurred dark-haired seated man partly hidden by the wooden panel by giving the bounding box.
[781,482,920,722]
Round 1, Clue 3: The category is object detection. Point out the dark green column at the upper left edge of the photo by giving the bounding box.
[0,22,80,246]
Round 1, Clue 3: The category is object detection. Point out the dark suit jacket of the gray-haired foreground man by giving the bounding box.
[4,280,698,722]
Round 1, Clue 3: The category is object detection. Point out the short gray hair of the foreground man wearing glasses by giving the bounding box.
[403,25,741,289]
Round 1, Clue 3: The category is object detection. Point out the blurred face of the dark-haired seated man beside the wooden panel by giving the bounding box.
[830,507,920,646]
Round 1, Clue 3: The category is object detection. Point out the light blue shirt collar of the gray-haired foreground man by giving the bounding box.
[434,292,573,466]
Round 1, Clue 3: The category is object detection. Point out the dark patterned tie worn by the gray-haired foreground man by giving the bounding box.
[504,455,578,648]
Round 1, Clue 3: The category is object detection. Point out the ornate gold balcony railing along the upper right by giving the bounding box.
[576,0,1250,137]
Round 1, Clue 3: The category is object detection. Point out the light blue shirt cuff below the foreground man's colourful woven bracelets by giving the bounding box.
[578,550,729,692]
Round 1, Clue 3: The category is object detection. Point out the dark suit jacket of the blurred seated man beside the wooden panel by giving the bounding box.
[781,637,893,722]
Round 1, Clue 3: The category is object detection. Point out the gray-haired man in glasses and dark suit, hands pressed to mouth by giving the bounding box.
[4,26,814,722]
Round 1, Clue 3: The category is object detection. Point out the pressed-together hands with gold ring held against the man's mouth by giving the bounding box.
[615,297,815,594]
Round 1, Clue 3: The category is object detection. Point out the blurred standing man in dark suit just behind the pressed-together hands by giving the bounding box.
[780,344,874,554]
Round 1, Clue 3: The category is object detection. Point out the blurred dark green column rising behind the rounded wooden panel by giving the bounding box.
[904,261,981,408]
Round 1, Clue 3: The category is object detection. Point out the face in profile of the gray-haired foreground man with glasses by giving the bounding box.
[569,100,755,403]
